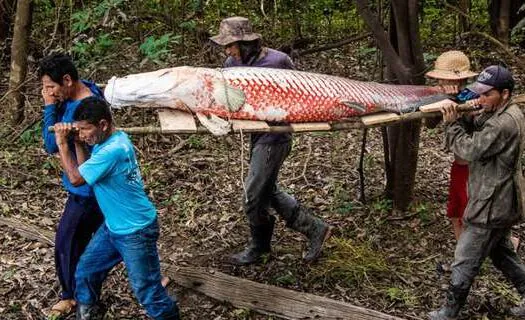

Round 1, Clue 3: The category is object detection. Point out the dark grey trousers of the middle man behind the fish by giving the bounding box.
[244,141,299,227]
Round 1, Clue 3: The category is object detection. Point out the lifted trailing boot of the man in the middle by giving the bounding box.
[288,206,332,263]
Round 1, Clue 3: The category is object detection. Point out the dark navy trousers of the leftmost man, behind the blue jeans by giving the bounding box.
[55,194,104,299]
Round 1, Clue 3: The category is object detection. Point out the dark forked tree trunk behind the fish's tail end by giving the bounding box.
[356,0,425,210]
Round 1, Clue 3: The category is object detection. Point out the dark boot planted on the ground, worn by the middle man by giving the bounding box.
[230,216,275,266]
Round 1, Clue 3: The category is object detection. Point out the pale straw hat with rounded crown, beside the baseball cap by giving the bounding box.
[426,51,478,80]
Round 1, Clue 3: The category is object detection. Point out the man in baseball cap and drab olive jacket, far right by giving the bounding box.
[429,66,525,320]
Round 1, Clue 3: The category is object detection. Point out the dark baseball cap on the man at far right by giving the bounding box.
[467,65,514,94]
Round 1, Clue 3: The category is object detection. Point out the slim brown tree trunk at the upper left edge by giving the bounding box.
[8,0,32,125]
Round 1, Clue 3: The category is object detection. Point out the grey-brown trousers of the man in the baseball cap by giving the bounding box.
[451,224,525,302]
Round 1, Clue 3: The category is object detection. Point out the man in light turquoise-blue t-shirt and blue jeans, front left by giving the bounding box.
[55,98,179,320]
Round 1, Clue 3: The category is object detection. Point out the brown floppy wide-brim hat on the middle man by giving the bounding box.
[210,17,261,46]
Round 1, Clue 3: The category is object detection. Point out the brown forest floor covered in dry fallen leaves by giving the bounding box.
[0,48,523,319]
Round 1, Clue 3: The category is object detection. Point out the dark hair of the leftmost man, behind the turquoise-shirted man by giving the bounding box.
[38,53,78,85]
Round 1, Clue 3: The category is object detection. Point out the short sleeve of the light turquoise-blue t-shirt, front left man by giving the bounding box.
[78,148,118,186]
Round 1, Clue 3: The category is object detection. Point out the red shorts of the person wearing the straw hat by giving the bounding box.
[447,161,468,221]
